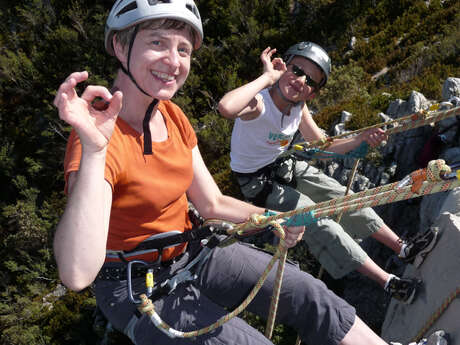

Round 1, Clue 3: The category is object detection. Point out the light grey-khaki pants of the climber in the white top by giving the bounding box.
[237,161,384,279]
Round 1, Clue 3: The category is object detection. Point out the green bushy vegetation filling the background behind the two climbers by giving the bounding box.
[0,0,460,345]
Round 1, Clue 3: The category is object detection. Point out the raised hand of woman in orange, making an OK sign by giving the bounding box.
[53,71,122,152]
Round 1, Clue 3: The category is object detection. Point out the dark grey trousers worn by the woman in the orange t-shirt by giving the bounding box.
[95,243,355,345]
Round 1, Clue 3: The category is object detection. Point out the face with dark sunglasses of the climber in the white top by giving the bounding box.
[279,56,323,102]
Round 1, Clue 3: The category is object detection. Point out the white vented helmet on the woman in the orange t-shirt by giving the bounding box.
[105,0,203,55]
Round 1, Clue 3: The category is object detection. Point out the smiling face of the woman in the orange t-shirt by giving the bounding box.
[121,28,193,100]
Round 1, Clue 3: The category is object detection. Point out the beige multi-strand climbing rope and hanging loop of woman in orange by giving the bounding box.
[138,159,460,338]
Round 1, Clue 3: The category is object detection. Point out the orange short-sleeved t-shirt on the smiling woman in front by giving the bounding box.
[64,101,197,260]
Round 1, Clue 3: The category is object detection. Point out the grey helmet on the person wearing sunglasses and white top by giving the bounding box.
[284,42,331,87]
